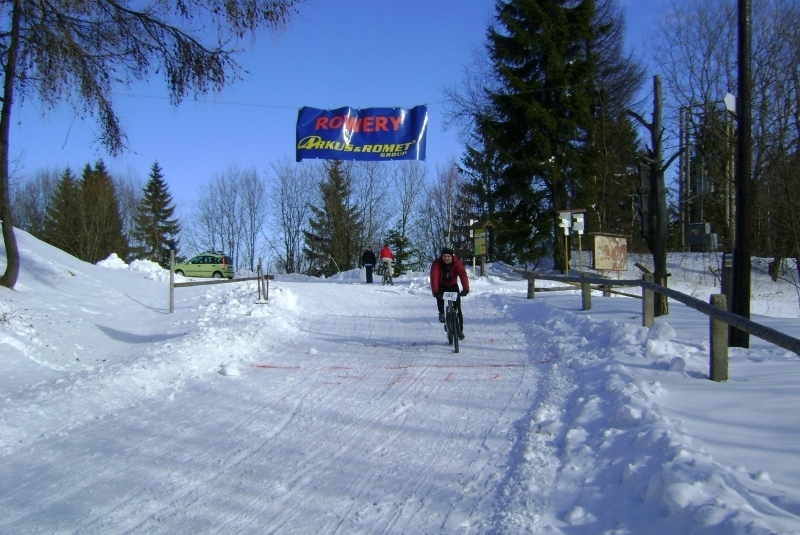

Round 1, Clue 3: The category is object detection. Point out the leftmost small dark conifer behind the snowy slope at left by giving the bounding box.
[43,168,83,257]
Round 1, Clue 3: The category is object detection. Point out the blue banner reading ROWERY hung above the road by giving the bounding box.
[297,106,428,162]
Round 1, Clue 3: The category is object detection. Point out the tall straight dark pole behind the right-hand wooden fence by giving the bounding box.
[728,0,755,347]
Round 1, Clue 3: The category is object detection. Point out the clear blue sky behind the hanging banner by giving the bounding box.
[11,0,654,207]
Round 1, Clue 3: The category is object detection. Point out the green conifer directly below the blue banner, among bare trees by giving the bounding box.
[303,161,362,277]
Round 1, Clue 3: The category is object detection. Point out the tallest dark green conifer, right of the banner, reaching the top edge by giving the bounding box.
[477,0,596,266]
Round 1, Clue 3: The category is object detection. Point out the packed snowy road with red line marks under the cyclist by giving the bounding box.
[0,274,558,534]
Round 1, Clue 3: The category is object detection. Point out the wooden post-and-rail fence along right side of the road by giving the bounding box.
[514,269,800,381]
